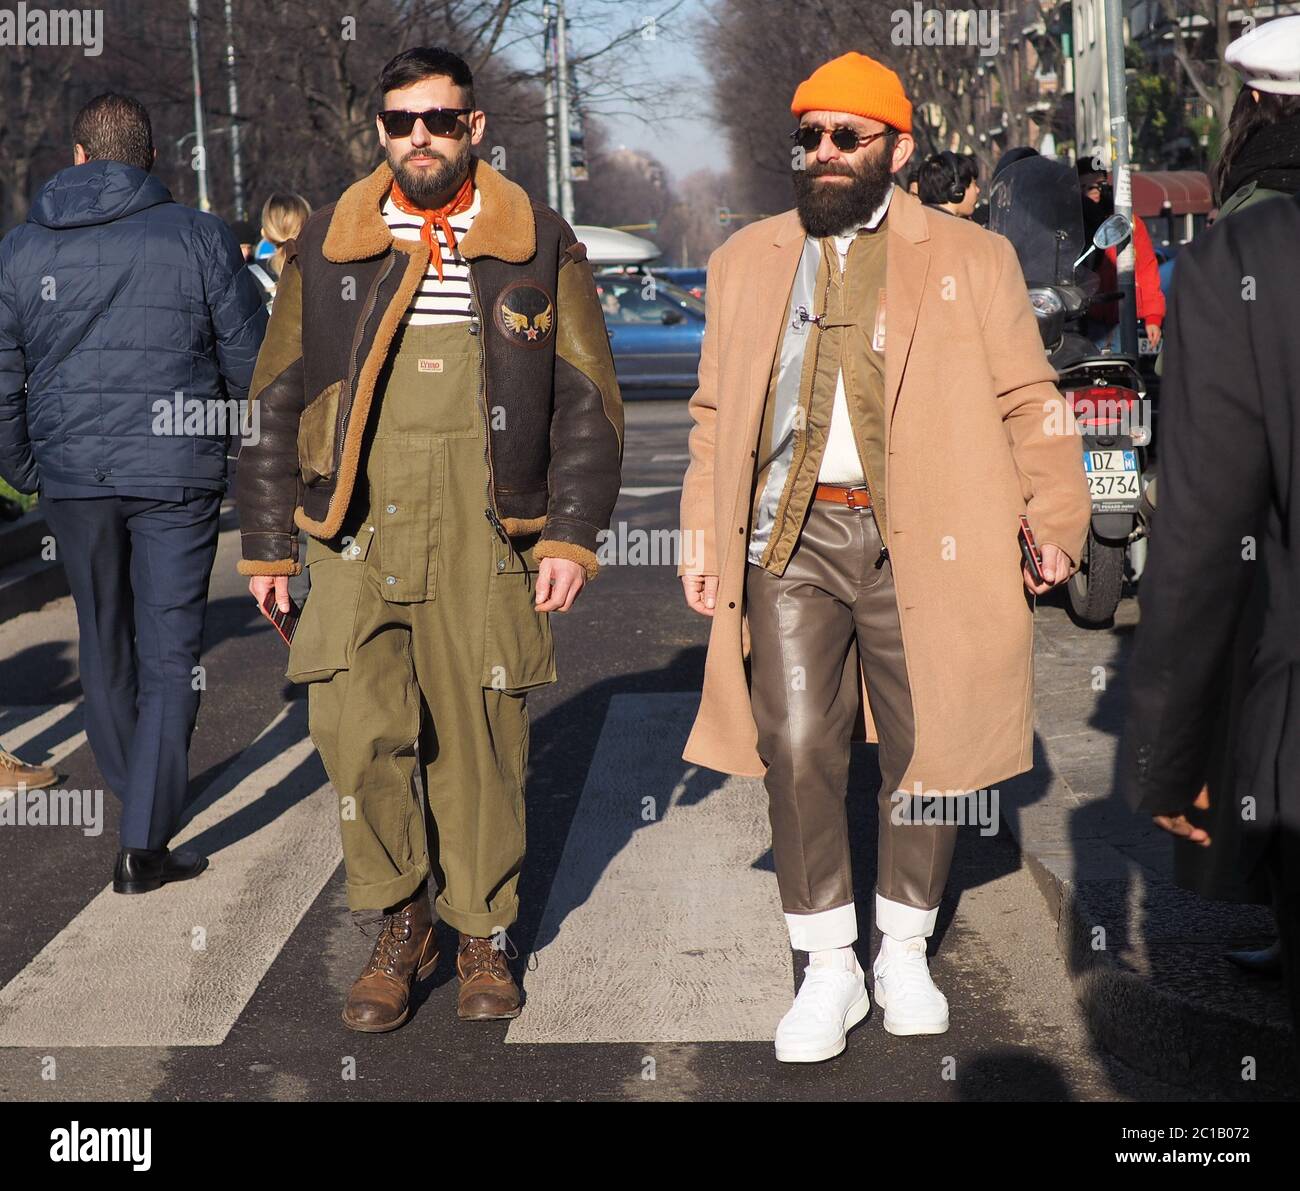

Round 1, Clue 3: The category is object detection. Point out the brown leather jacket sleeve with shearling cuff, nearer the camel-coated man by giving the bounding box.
[534,232,623,577]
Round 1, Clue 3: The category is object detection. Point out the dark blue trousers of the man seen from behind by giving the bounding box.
[40,491,221,849]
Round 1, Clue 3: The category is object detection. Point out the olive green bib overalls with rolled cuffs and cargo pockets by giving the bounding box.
[287,322,555,936]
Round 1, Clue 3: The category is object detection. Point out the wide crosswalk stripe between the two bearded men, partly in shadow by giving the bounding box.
[506,693,792,1043]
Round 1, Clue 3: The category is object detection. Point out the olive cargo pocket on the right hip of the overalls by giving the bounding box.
[482,540,555,690]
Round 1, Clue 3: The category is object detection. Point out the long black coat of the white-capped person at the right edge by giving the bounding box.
[1117,198,1300,1022]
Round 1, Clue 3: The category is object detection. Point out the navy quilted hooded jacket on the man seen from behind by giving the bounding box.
[0,161,267,494]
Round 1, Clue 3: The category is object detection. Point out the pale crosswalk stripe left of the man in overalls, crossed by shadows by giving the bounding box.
[0,701,342,1048]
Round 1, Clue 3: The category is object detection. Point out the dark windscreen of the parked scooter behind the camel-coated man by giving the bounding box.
[988,156,1084,286]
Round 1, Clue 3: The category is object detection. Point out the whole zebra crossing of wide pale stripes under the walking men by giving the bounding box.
[0,693,789,1049]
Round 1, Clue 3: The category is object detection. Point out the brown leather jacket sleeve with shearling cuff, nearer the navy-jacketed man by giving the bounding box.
[235,241,306,575]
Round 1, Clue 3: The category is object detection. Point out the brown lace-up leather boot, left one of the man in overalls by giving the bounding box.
[343,885,438,1034]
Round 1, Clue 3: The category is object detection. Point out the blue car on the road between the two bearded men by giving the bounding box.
[595,272,705,398]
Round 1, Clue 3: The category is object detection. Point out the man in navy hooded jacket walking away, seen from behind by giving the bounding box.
[0,94,267,893]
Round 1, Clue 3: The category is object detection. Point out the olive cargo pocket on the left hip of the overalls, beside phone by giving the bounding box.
[285,527,374,683]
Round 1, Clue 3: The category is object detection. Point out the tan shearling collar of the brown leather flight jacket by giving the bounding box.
[321,157,537,264]
